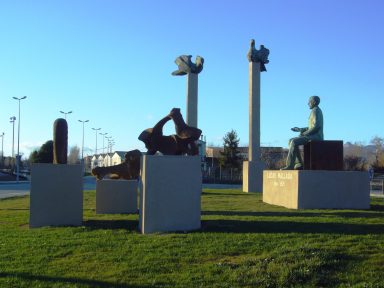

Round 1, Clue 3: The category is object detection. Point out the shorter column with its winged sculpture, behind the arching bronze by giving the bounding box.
[172,55,204,127]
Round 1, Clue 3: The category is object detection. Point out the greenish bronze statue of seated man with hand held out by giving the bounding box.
[282,96,324,170]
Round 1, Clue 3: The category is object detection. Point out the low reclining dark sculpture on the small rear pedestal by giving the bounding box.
[92,149,141,180]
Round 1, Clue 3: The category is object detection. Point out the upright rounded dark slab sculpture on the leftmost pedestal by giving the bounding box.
[53,118,68,164]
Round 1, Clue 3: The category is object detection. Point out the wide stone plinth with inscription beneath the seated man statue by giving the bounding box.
[263,170,370,209]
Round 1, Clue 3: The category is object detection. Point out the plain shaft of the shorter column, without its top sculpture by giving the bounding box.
[186,73,199,127]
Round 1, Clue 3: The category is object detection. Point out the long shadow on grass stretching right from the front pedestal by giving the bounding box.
[201,220,384,235]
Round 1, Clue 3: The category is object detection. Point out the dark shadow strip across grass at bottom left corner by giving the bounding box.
[0,272,150,288]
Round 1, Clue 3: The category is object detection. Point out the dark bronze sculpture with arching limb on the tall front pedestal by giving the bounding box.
[139,108,201,155]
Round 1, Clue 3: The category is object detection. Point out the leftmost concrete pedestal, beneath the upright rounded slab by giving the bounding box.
[29,164,83,227]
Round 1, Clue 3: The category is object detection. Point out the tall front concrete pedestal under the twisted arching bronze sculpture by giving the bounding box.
[139,155,202,234]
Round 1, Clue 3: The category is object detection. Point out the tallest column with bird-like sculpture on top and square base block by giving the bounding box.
[243,39,269,192]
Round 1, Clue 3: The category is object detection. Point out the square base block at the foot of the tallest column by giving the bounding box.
[243,161,265,192]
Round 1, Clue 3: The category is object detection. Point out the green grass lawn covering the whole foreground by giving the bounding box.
[0,190,384,287]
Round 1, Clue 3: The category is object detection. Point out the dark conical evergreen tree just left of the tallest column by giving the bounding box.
[219,130,242,168]
